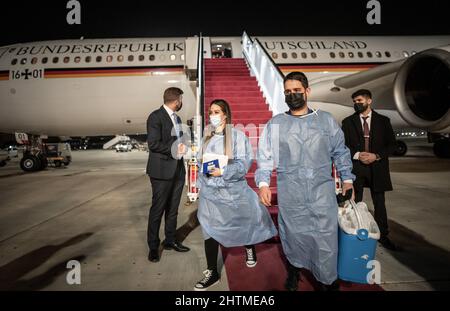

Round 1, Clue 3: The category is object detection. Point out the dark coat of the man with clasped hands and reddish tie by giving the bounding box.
[342,110,395,192]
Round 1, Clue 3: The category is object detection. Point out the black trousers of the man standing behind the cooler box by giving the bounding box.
[353,166,389,238]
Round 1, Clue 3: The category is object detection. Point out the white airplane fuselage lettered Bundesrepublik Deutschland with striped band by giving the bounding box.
[0,36,450,136]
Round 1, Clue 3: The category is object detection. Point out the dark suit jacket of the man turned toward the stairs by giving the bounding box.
[147,106,185,180]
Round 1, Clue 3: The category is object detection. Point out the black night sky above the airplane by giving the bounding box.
[0,0,450,45]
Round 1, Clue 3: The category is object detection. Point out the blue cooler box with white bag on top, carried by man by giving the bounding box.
[338,201,380,284]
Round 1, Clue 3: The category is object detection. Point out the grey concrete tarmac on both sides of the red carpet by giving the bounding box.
[0,139,450,291]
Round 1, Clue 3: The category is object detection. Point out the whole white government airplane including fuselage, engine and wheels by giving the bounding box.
[0,33,450,171]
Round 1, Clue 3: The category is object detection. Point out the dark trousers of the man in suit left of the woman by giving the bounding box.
[147,160,185,250]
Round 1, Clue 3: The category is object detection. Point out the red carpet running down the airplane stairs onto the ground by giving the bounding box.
[204,58,382,291]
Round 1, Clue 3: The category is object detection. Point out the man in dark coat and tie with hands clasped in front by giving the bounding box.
[342,89,397,250]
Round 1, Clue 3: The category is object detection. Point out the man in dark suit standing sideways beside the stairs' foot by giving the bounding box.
[147,87,189,262]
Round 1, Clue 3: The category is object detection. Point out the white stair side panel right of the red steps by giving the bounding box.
[242,31,289,115]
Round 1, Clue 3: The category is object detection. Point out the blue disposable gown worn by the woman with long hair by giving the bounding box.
[197,129,277,247]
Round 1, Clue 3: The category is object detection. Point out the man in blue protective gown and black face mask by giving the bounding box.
[255,72,355,291]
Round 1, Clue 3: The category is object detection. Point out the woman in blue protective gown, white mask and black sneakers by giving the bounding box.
[194,99,277,290]
